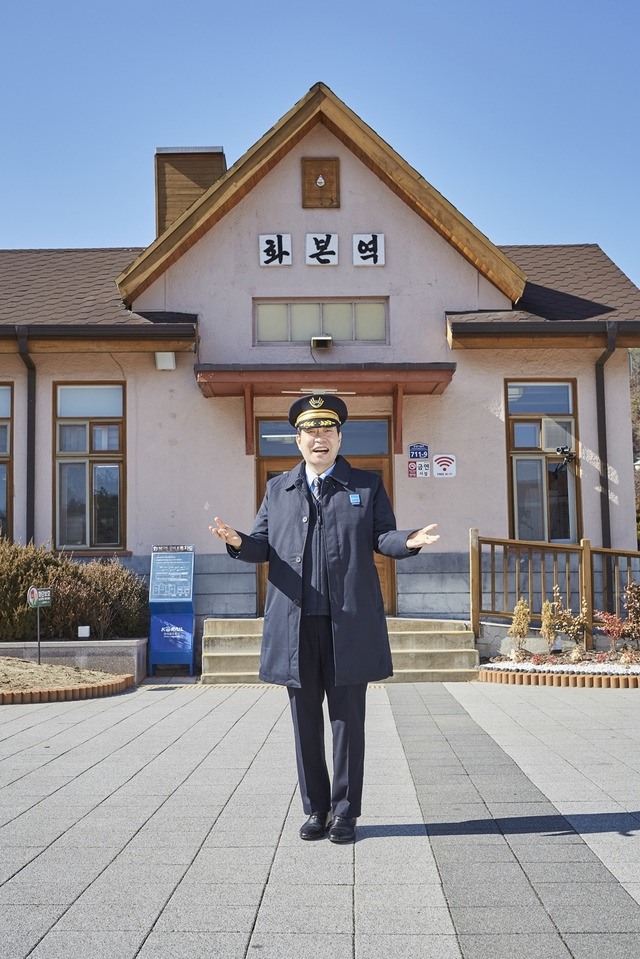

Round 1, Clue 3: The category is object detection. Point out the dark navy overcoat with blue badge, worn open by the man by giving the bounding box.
[228,456,419,686]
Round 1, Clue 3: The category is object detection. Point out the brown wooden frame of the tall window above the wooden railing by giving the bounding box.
[504,377,582,544]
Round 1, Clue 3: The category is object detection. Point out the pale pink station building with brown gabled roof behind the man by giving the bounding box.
[0,83,640,652]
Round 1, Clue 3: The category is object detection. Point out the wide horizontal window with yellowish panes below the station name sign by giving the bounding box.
[254,299,388,346]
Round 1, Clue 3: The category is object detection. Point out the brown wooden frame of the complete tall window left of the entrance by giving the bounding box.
[53,380,127,554]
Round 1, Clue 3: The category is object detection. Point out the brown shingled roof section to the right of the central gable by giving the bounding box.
[447,243,640,349]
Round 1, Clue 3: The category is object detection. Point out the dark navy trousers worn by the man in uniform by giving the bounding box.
[288,616,367,819]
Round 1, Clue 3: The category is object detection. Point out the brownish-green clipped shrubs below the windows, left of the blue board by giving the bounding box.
[0,539,148,641]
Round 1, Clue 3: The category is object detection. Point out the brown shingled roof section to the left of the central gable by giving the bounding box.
[0,247,197,353]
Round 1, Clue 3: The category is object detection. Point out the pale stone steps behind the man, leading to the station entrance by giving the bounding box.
[201,617,479,685]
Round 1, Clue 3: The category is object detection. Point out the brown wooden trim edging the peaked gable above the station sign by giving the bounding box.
[117,83,526,305]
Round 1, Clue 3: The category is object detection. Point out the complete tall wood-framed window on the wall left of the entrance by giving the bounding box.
[55,384,124,549]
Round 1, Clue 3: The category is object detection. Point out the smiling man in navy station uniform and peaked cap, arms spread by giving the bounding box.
[210,394,439,843]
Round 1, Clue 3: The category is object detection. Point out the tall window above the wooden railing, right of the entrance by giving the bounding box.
[507,382,578,543]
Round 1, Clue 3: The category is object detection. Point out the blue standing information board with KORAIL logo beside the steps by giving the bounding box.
[149,546,195,676]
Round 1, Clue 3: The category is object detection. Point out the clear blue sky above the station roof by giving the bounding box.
[0,0,640,285]
